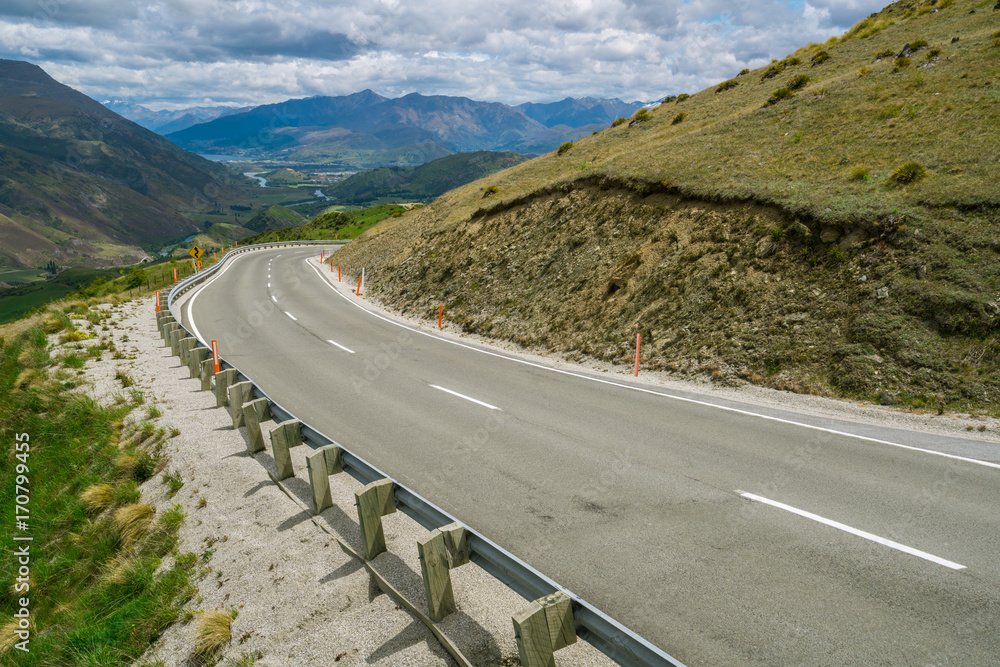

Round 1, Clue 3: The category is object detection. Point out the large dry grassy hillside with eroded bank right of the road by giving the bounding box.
[338,0,1000,413]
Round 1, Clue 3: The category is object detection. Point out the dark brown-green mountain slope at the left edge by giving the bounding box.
[0,60,248,267]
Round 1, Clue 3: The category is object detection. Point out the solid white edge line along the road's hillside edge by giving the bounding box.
[298,264,1000,470]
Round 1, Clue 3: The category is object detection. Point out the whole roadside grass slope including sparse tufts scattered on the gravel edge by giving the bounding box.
[0,301,197,666]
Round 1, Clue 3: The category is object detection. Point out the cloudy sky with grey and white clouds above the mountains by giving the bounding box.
[0,0,888,110]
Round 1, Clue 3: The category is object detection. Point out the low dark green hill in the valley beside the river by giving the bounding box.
[324,151,527,205]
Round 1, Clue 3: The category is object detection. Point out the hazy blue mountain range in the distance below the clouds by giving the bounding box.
[166,90,643,169]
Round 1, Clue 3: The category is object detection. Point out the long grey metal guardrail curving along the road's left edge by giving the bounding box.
[167,241,684,667]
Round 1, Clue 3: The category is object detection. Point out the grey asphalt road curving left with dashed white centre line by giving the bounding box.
[182,248,1000,665]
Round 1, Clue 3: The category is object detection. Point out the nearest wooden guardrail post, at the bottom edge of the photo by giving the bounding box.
[511,591,576,667]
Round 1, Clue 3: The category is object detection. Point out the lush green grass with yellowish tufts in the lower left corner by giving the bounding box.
[0,329,195,666]
